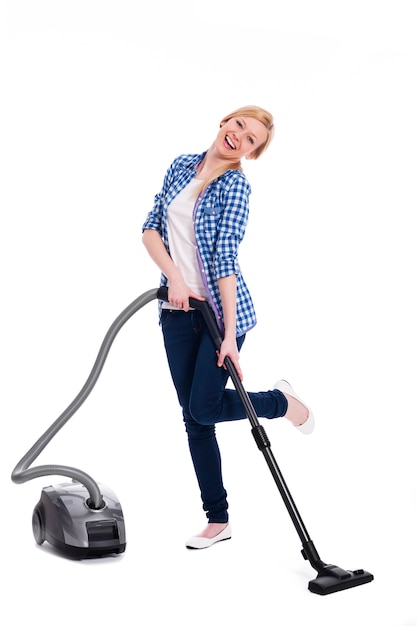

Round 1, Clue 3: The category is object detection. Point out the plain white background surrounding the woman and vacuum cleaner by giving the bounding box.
[0,0,417,626]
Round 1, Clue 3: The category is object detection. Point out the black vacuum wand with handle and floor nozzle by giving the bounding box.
[158,287,374,595]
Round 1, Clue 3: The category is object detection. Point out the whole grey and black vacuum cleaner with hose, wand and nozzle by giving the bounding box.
[11,287,374,595]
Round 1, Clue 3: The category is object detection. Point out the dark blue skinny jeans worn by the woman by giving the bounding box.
[161,309,288,523]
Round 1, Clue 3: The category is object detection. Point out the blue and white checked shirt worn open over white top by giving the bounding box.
[142,153,256,337]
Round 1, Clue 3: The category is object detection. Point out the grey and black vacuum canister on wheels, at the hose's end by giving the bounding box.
[32,482,126,559]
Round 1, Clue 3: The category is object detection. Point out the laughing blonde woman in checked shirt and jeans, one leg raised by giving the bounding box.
[143,106,314,548]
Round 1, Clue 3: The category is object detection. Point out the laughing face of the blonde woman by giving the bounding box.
[215,116,268,161]
